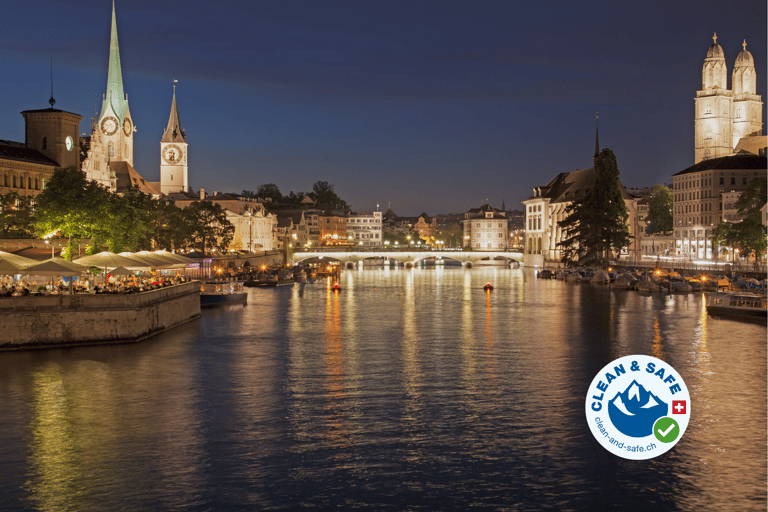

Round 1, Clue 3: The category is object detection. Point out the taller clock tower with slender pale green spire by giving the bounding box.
[94,1,135,166]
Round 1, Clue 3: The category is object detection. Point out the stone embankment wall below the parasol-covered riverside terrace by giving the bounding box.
[0,281,200,350]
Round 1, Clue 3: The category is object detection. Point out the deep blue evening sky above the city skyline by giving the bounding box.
[0,0,768,215]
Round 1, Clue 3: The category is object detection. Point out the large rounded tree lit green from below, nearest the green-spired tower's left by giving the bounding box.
[35,167,111,259]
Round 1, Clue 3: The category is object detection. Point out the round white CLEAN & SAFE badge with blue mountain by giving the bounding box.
[586,355,691,460]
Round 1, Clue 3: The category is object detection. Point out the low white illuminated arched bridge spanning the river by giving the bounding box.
[293,249,523,267]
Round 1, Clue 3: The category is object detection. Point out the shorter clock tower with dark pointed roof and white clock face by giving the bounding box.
[160,85,189,194]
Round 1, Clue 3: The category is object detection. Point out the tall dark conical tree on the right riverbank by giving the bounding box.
[558,149,630,266]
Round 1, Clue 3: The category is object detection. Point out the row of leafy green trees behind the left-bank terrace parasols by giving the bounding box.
[8,167,235,258]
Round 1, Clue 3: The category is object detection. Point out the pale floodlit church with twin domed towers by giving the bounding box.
[694,35,763,163]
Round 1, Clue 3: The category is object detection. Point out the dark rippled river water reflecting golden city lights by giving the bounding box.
[0,267,767,511]
